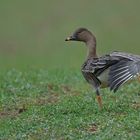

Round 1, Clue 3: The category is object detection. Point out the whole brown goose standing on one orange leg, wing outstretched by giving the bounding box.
[66,28,140,107]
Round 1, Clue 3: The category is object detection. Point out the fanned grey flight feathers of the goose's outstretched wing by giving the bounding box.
[109,52,140,92]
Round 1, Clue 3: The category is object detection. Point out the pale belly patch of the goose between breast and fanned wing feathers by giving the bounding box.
[98,68,110,88]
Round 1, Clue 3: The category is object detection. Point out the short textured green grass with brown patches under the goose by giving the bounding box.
[0,69,140,140]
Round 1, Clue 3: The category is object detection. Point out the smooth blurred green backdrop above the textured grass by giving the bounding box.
[0,0,140,69]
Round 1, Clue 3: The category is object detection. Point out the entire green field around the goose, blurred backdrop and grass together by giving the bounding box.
[0,0,140,140]
